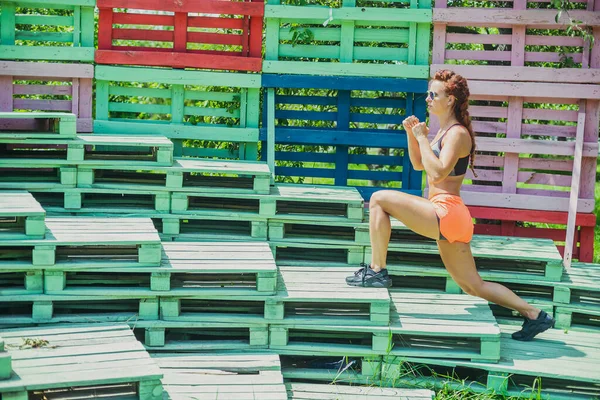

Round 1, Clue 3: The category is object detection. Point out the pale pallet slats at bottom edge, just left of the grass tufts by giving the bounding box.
[285,382,435,400]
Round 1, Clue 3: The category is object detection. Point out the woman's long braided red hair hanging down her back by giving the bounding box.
[433,69,477,177]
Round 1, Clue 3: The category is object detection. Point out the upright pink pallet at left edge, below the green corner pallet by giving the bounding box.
[0,61,94,132]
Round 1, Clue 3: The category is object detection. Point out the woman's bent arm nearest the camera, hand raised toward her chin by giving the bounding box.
[413,123,471,183]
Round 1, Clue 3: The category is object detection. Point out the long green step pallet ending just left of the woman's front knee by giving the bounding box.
[171,184,364,222]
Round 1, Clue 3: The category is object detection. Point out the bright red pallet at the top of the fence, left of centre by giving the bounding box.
[96,0,265,71]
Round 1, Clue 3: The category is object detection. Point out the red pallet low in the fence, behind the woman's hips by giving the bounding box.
[469,206,596,262]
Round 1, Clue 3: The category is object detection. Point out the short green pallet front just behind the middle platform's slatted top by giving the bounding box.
[161,214,267,242]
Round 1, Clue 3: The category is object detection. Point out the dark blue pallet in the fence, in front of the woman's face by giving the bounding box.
[260,74,427,200]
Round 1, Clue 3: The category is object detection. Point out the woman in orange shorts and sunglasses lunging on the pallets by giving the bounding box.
[346,70,554,341]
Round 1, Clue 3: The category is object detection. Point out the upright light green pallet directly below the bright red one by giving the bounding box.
[94,65,261,160]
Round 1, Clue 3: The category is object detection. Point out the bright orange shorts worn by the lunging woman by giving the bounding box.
[429,193,474,243]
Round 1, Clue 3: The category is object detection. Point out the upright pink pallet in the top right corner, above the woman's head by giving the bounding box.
[431,0,600,84]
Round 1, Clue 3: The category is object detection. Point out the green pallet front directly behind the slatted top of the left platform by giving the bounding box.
[39,188,171,214]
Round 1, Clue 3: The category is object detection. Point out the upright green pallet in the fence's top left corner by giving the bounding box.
[0,0,95,62]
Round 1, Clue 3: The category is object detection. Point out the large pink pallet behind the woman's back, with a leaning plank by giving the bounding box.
[431,80,600,213]
